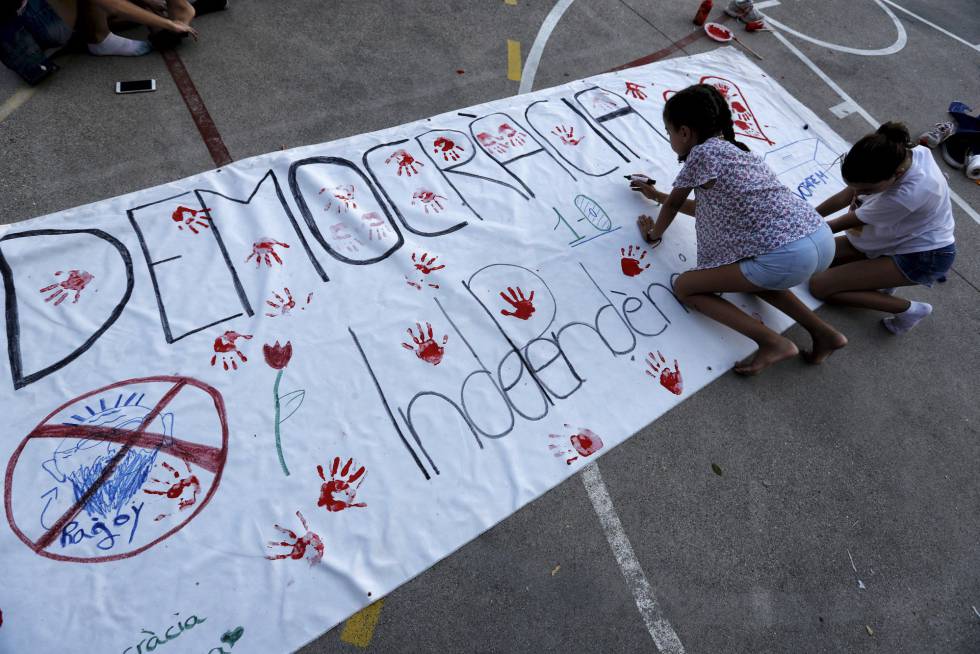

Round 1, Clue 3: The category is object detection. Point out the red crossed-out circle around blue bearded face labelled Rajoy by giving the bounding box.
[4,376,228,563]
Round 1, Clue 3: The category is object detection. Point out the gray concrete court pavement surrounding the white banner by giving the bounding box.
[0,0,980,654]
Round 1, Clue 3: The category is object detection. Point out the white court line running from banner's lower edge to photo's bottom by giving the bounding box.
[582,463,684,654]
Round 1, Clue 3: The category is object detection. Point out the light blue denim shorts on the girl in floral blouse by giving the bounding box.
[738,223,835,291]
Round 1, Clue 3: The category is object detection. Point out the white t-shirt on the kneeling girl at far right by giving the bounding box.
[847,146,955,258]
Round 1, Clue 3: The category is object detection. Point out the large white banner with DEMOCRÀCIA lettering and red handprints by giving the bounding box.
[0,49,845,654]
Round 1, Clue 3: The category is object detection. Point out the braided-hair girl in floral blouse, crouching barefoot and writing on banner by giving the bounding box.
[631,84,847,375]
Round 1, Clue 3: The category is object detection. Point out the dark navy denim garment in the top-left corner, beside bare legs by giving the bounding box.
[0,0,72,84]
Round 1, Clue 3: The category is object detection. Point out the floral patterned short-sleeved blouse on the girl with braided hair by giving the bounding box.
[674,137,824,270]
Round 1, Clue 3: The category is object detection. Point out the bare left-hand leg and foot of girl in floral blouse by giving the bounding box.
[674,263,799,375]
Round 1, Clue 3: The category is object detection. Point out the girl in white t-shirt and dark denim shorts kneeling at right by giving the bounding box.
[810,123,956,334]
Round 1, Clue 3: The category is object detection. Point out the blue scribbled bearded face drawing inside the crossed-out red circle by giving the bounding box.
[41,393,174,528]
